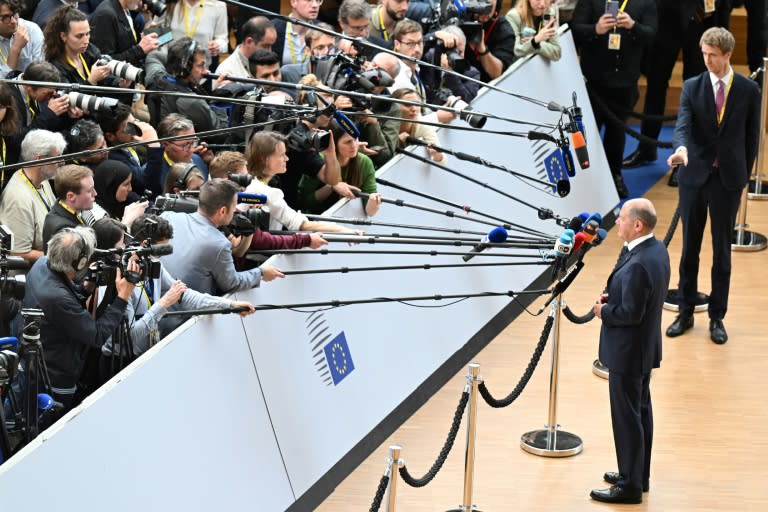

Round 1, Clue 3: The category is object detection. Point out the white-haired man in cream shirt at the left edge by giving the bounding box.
[0,130,67,264]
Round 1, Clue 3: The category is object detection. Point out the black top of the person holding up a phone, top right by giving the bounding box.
[571,0,657,88]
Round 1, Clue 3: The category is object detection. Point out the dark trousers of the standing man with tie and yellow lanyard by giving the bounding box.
[678,173,741,320]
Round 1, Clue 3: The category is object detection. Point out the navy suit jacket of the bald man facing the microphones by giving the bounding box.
[600,238,670,376]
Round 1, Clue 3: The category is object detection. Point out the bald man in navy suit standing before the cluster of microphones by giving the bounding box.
[590,198,670,503]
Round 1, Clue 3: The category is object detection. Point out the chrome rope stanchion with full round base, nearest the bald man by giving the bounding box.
[520,294,584,457]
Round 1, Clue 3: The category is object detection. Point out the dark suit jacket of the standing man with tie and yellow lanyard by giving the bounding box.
[673,72,760,191]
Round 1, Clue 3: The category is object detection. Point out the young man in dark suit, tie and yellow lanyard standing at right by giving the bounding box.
[667,27,760,344]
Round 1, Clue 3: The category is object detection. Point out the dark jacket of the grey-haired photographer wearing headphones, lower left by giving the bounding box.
[23,257,128,388]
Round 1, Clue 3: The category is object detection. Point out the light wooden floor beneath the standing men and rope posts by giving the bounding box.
[318,170,768,512]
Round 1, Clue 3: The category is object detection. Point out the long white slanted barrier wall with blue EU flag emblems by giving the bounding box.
[0,33,617,511]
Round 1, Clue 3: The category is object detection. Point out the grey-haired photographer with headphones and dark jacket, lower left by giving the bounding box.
[23,227,138,414]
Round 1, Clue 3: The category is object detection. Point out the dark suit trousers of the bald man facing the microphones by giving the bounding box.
[608,372,653,492]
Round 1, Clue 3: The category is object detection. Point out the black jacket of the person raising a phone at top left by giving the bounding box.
[91,0,145,67]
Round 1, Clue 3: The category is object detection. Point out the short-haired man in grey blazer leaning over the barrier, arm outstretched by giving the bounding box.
[162,179,283,295]
